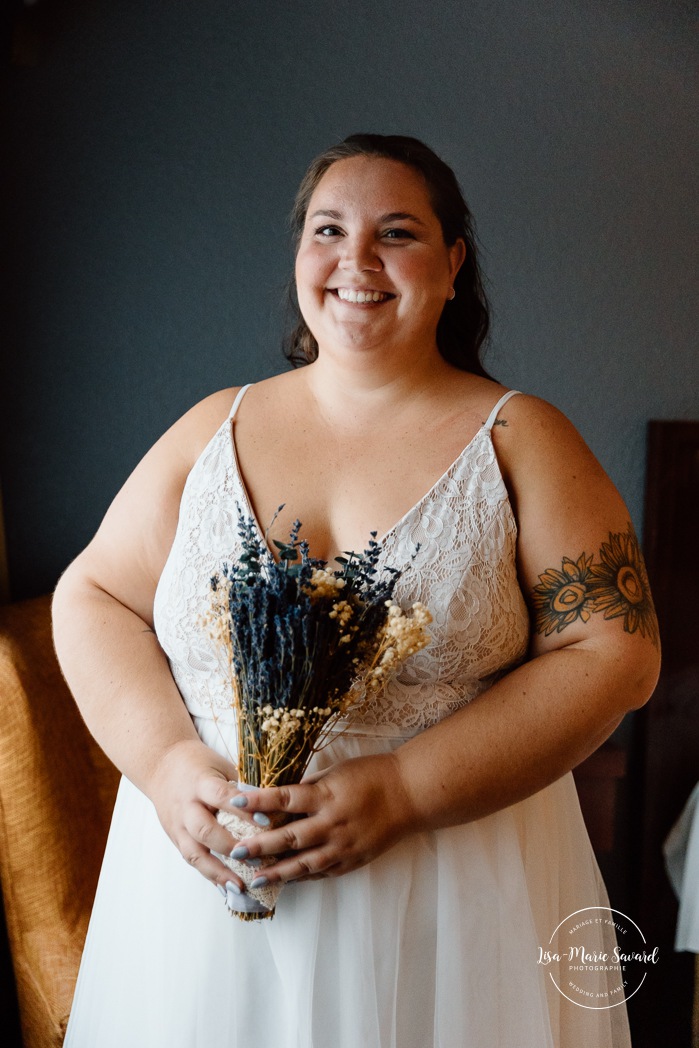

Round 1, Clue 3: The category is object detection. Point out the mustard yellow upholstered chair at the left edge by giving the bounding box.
[0,596,118,1048]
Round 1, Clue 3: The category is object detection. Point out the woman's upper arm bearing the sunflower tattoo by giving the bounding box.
[496,397,659,705]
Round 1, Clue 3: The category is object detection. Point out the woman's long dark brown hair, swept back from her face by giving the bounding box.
[284,134,490,377]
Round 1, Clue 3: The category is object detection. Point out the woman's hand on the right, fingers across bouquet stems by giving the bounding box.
[221,754,415,887]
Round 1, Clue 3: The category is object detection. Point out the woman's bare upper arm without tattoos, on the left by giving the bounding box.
[58,390,235,625]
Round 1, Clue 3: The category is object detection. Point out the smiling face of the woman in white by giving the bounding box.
[296,156,465,360]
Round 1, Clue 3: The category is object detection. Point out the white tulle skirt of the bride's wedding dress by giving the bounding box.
[65,718,630,1048]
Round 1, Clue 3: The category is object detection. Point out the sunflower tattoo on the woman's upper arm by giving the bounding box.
[532,523,659,647]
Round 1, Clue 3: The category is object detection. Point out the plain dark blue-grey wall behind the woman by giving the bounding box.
[0,0,699,597]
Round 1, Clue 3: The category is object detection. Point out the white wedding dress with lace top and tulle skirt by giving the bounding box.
[65,389,630,1048]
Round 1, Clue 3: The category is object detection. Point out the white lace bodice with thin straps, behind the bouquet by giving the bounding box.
[155,389,529,738]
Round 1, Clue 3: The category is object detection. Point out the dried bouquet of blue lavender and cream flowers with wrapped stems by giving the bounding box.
[207,506,432,920]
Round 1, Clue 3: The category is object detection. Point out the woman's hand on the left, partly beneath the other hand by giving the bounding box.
[147,739,259,894]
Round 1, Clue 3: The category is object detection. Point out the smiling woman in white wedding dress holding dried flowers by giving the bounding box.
[51,135,658,1048]
